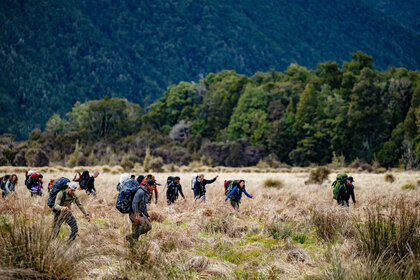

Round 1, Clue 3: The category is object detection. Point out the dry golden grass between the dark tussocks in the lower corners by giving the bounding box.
[0,166,420,279]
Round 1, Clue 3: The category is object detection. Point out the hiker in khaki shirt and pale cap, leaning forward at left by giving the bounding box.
[52,182,90,242]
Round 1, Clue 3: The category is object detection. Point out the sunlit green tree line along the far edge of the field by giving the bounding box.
[0,52,420,170]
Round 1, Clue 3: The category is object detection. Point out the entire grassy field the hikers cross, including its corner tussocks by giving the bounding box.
[0,168,420,279]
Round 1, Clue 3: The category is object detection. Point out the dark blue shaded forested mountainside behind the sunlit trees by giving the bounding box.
[0,0,420,139]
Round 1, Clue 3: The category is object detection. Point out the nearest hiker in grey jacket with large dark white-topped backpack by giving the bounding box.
[116,173,152,245]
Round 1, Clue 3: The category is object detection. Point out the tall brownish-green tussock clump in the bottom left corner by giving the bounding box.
[0,215,97,279]
